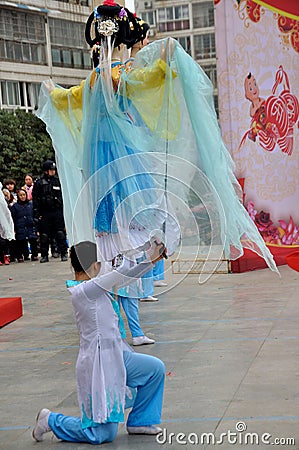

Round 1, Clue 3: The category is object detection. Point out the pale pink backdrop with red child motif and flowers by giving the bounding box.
[215,0,299,251]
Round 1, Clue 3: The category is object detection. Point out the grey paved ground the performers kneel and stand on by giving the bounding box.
[0,259,299,450]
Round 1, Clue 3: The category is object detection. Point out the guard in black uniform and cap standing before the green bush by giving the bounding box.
[32,160,67,263]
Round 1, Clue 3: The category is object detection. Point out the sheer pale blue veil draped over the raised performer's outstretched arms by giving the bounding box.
[38,39,277,271]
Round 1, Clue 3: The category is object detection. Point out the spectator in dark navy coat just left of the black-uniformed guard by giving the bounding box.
[11,189,38,262]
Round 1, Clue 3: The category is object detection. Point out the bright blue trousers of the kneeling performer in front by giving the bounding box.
[48,352,165,444]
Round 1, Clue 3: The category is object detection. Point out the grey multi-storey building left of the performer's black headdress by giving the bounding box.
[0,0,92,111]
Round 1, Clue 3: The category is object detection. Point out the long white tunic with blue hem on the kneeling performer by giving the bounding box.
[69,255,153,428]
